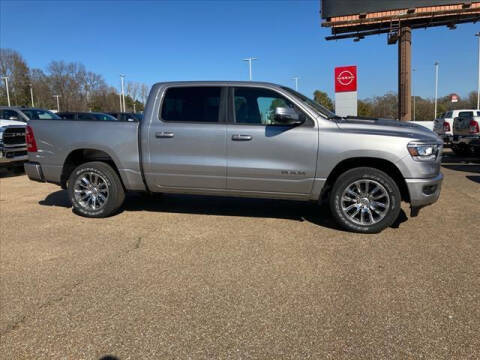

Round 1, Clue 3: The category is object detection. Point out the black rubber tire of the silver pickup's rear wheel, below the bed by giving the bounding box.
[67,161,125,218]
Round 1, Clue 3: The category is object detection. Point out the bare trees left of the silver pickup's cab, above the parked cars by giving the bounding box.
[0,48,149,111]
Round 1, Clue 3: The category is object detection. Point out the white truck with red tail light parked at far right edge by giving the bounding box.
[452,111,480,155]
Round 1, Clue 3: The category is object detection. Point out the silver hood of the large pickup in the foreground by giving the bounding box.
[337,117,442,143]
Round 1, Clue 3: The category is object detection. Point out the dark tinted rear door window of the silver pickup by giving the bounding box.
[161,86,221,123]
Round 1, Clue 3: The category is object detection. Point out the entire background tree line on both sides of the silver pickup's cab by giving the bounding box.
[0,48,477,120]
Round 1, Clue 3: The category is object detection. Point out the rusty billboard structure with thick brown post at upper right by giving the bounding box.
[322,0,480,121]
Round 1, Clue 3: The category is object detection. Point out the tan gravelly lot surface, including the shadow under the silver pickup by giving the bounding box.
[0,150,480,360]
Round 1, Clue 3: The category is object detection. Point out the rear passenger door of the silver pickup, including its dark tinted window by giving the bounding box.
[145,86,227,191]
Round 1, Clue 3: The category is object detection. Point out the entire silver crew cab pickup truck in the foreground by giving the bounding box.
[25,82,443,233]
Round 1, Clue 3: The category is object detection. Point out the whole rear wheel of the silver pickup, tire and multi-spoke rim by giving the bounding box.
[68,161,125,218]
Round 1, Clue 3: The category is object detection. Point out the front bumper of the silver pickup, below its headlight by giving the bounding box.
[405,173,443,211]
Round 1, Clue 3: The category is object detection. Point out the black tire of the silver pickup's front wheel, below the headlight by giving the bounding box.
[329,167,401,234]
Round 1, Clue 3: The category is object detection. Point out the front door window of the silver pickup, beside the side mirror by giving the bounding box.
[234,87,295,125]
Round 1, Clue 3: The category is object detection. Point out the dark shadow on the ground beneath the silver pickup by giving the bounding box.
[39,190,408,231]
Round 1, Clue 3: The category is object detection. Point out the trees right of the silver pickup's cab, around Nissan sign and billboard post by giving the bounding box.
[313,90,477,121]
